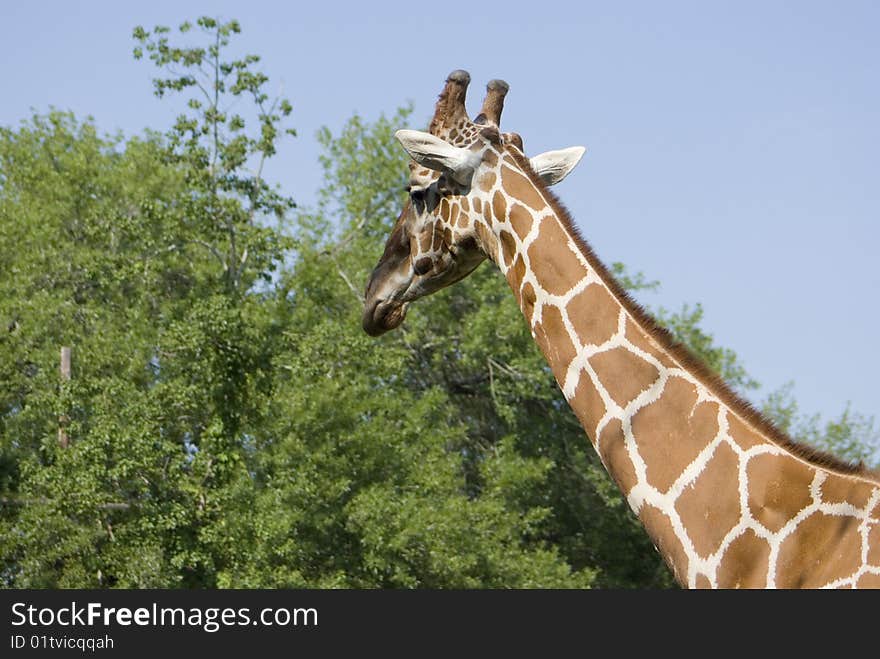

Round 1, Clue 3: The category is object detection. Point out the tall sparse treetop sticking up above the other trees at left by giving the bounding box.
[134,16,296,292]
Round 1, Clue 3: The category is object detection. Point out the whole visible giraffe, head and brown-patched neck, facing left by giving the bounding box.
[363,71,880,588]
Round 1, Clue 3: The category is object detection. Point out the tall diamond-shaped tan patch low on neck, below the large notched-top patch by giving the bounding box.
[675,440,741,558]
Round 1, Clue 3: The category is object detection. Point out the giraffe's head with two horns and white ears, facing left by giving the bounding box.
[363,70,584,336]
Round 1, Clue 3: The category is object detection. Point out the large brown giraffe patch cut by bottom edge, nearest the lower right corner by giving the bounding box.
[776,512,862,588]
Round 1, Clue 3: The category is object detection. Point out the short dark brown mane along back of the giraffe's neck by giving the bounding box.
[505,149,880,481]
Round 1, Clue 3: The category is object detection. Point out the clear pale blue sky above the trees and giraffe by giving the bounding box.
[0,0,880,426]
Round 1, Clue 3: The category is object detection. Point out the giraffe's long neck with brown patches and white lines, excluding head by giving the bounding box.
[478,154,880,587]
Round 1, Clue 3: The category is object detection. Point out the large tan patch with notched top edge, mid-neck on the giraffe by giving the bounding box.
[632,378,718,492]
